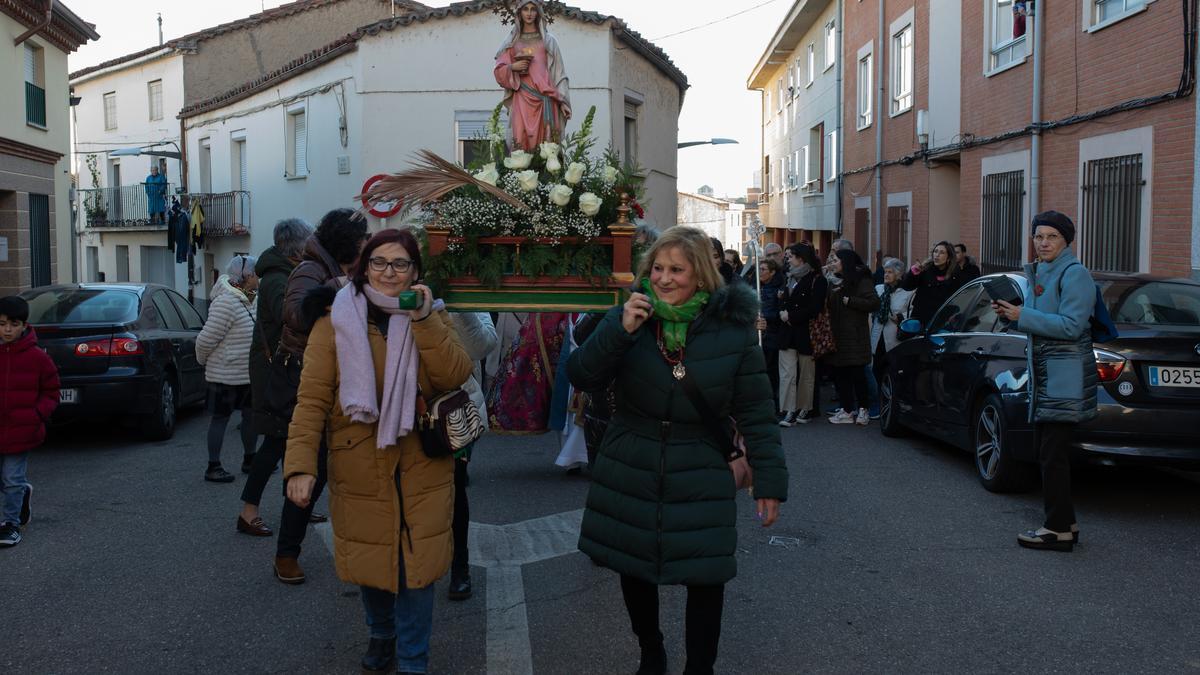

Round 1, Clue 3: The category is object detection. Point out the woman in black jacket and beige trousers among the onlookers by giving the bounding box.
[779,244,829,426]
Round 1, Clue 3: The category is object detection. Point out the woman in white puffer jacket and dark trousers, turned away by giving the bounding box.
[196,256,258,483]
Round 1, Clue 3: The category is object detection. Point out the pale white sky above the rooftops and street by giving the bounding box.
[65,0,792,197]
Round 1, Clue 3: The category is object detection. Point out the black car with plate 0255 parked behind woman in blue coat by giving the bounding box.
[880,273,1200,491]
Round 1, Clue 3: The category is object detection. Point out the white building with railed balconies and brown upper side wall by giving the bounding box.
[70,0,426,292]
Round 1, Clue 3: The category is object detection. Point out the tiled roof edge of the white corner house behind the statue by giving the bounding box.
[179,0,689,118]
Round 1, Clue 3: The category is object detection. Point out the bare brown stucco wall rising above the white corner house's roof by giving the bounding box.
[184,0,400,104]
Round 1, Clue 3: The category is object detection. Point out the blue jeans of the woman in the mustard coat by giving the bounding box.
[359,578,433,673]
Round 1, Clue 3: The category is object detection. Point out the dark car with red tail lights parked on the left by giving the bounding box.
[20,283,208,440]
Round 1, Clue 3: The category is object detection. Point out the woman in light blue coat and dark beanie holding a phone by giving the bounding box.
[994,211,1097,551]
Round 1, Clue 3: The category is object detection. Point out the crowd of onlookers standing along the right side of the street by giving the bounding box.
[714,239,979,428]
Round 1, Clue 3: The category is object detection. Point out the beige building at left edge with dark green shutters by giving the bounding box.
[0,0,100,295]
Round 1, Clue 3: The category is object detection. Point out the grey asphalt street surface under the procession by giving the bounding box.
[0,398,1200,675]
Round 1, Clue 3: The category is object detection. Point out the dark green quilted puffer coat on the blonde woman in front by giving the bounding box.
[566,285,787,585]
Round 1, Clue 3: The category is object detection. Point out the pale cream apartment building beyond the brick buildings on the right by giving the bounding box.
[746,0,845,249]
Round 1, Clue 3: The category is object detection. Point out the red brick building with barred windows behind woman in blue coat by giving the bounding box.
[960,0,1200,276]
